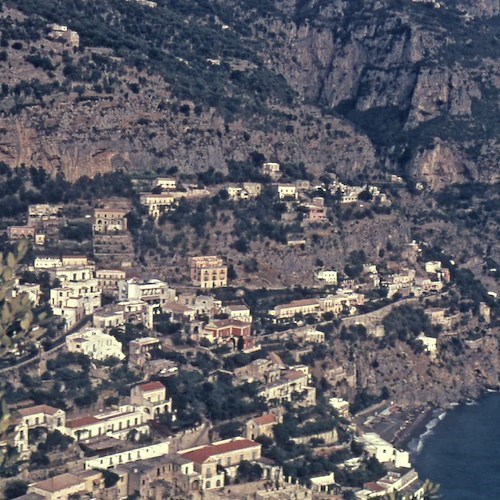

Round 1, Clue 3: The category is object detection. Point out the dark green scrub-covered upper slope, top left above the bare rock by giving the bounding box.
[6,0,294,115]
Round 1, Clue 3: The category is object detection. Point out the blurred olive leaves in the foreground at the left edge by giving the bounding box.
[0,240,44,464]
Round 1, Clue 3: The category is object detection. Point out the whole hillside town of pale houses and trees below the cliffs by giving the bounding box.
[0,163,496,500]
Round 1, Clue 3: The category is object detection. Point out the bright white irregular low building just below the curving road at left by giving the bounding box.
[66,327,125,361]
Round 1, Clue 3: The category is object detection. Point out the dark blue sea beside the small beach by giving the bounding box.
[412,393,500,500]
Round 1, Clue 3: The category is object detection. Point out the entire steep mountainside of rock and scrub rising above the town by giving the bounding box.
[0,0,500,188]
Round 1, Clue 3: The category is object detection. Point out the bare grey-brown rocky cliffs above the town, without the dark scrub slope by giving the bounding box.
[0,0,500,188]
